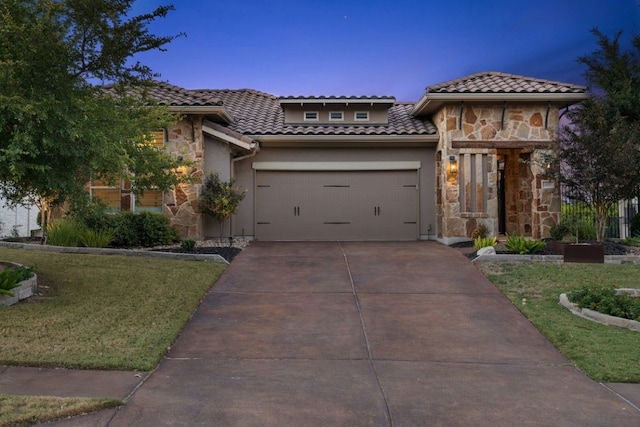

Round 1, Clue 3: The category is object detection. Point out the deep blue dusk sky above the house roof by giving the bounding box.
[132,0,640,101]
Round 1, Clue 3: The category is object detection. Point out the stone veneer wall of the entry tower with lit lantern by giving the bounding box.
[433,104,560,243]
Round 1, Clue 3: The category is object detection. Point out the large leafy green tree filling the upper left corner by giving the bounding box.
[0,0,189,224]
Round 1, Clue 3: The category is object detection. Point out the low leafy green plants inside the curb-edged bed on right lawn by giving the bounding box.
[567,285,640,321]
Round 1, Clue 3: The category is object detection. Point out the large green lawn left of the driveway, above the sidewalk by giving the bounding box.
[0,248,224,371]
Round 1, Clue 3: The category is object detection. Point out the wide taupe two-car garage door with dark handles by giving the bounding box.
[255,170,419,240]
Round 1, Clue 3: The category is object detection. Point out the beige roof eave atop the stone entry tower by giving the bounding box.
[411,92,589,117]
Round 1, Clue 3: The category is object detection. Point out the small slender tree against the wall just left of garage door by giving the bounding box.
[198,172,246,238]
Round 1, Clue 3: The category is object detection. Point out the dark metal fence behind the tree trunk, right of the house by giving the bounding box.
[561,198,640,239]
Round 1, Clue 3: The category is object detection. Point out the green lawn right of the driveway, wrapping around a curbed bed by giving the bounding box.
[479,263,640,383]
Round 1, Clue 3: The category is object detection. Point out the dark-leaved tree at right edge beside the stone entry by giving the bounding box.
[559,29,640,241]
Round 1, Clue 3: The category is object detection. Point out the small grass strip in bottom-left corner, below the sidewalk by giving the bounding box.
[0,394,123,427]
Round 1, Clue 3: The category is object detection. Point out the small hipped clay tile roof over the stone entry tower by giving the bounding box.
[427,71,587,94]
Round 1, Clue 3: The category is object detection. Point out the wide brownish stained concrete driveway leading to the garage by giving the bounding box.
[51,242,640,427]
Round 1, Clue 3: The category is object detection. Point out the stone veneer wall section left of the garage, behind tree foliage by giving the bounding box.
[163,117,204,239]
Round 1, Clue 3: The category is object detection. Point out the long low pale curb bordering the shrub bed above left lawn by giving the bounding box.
[0,242,229,264]
